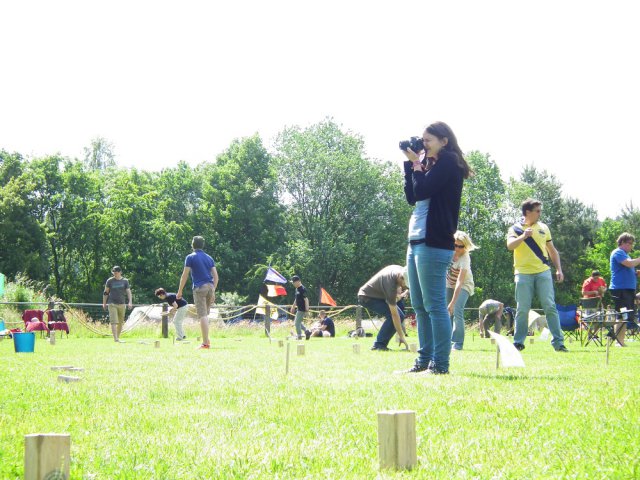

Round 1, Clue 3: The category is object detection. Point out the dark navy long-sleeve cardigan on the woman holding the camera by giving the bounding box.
[404,150,464,250]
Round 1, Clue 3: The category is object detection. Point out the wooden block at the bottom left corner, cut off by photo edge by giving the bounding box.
[24,433,71,480]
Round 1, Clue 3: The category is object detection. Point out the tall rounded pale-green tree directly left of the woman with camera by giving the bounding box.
[275,119,410,303]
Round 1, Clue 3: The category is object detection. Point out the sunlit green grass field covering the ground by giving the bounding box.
[0,320,640,479]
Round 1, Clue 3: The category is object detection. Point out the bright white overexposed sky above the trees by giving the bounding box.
[0,0,640,218]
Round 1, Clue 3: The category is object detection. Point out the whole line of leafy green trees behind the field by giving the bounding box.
[0,119,640,307]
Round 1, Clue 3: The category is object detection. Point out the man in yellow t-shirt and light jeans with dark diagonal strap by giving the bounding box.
[507,198,567,352]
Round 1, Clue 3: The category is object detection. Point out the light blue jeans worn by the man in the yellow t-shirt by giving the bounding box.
[513,270,564,348]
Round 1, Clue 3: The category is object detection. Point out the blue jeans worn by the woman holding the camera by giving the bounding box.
[407,243,453,371]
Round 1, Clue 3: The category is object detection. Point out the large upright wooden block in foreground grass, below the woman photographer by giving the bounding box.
[378,410,418,469]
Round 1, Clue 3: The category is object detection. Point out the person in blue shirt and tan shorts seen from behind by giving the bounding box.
[176,235,218,349]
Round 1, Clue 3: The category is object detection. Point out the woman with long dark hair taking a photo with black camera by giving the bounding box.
[403,122,471,375]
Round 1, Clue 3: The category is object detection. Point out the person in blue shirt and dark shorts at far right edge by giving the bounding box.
[609,232,640,347]
